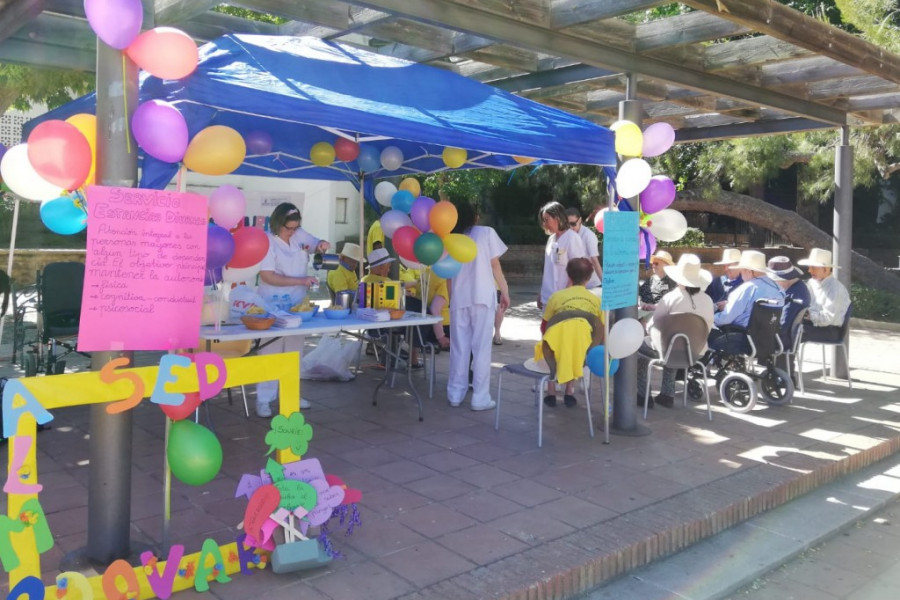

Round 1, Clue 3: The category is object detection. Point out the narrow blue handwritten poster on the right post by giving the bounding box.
[600,211,640,310]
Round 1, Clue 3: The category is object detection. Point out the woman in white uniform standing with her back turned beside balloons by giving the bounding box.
[447,203,509,410]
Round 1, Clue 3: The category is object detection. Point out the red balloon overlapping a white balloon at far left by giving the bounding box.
[28,119,94,190]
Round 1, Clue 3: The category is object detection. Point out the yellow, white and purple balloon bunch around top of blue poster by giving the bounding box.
[594,120,687,259]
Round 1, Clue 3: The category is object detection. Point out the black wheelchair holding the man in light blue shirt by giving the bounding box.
[686,300,794,413]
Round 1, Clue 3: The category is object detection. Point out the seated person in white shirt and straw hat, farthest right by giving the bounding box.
[797,248,850,342]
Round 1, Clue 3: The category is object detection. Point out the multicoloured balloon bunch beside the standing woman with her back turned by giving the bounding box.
[375,178,477,279]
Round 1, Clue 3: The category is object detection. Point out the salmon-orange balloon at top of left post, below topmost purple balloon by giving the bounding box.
[125,27,199,79]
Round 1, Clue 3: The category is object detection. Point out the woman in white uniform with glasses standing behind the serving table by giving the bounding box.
[256,202,330,418]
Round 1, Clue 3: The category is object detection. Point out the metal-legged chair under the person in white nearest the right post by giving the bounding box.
[644,313,712,421]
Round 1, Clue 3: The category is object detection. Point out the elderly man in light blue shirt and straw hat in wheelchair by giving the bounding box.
[709,250,784,354]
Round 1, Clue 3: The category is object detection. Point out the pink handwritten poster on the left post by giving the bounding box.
[78,186,207,352]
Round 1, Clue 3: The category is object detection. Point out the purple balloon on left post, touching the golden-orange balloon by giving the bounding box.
[131,100,188,163]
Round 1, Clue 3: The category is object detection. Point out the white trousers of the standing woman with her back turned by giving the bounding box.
[447,304,495,406]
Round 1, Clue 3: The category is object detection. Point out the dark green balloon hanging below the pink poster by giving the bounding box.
[166,419,222,485]
